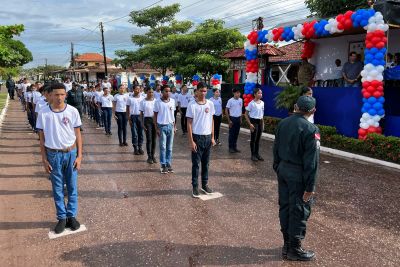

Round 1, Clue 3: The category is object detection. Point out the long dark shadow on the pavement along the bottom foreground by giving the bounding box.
[61,240,281,266]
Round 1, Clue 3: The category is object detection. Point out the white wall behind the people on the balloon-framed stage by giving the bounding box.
[310,29,400,80]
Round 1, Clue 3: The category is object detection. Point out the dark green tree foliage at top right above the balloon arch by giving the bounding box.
[304,0,368,18]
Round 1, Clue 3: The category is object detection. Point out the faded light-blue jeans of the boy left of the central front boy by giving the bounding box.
[158,124,174,167]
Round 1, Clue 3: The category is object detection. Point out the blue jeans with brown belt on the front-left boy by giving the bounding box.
[46,149,78,220]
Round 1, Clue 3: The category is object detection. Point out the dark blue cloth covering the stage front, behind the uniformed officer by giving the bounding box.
[262,86,362,138]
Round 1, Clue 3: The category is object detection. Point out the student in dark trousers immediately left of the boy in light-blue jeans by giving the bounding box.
[139,88,157,164]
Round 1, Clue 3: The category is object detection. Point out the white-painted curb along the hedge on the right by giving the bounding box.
[221,123,400,170]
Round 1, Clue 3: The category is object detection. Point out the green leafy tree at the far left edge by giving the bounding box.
[0,24,33,68]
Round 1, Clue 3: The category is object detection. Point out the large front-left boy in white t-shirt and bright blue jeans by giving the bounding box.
[36,83,82,234]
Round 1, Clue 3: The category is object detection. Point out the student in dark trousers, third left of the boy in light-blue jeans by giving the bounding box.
[113,84,129,146]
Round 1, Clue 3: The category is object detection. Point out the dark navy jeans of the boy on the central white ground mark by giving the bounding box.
[192,134,211,187]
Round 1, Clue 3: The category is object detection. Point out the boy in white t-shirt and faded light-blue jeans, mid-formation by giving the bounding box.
[154,85,176,173]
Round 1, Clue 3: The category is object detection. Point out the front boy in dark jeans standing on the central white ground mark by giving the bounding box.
[186,82,215,198]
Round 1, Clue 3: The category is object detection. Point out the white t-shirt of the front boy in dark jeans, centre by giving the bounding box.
[186,100,215,135]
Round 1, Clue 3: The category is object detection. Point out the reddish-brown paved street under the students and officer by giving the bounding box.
[0,101,400,266]
